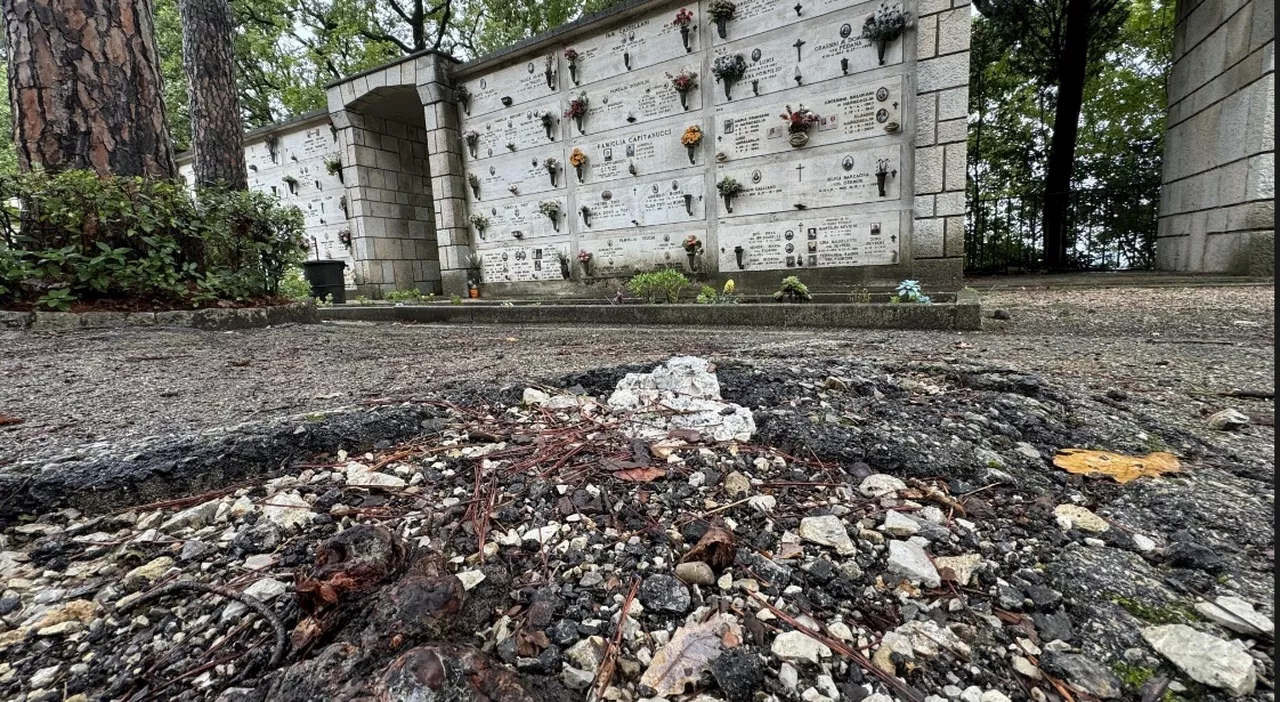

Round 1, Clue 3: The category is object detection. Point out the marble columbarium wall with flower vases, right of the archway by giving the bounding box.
[445,0,970,293]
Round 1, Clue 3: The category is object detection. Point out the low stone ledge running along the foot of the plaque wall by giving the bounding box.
[319,293,982,331]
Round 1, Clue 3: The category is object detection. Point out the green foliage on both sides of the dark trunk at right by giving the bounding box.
[966,0,1174,266]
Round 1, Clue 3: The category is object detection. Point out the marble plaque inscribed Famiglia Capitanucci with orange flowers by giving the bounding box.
[568,118,712,184]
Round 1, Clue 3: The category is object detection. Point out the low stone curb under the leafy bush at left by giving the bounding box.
[0,302,320,332]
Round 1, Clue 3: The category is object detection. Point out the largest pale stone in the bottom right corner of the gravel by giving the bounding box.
[1142,624,1257,696]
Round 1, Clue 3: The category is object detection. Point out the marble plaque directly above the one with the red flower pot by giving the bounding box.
[705,13,902,105]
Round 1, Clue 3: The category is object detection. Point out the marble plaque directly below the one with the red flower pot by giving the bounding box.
[716,145,902,218]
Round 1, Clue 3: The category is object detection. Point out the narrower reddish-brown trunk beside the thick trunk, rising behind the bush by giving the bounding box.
[178,0,248,190]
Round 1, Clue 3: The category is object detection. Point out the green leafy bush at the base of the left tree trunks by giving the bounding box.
[0,170,306,309]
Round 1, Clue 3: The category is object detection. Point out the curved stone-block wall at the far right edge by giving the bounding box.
[1156,0,1275,275]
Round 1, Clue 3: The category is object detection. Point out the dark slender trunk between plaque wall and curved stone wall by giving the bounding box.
[1044,0,1093,270]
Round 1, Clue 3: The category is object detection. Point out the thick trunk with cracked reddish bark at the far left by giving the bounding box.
[4,0,178,177]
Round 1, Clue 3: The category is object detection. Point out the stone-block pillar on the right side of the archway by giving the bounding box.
[417,56,475,297]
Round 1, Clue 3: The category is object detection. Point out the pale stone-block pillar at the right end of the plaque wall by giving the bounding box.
[911,0,970,284]
